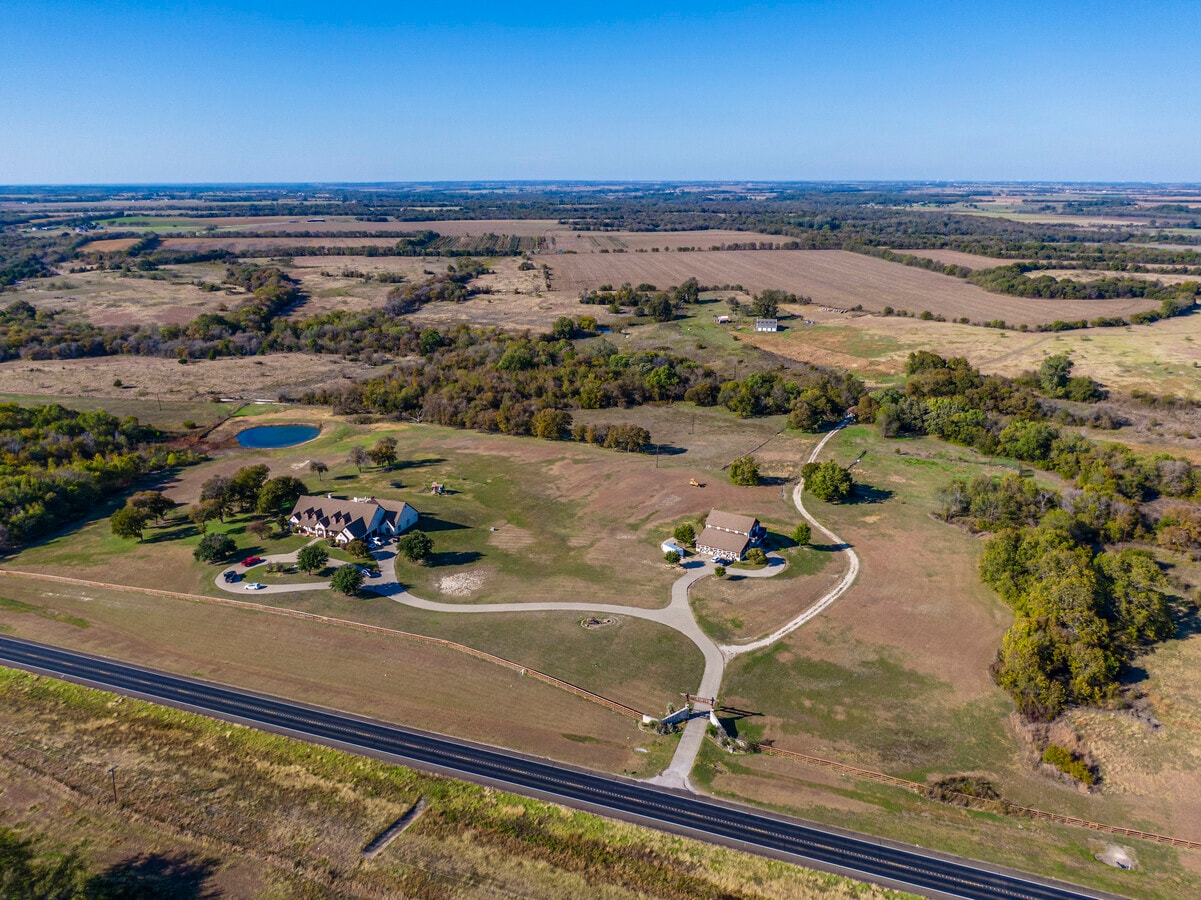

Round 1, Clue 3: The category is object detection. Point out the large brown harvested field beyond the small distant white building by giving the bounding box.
[550,250,1155,324]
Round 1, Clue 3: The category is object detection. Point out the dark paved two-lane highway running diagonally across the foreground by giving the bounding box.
[0,636,1095,900]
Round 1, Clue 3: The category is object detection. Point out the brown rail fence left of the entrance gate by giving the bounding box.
[0,568,644,721]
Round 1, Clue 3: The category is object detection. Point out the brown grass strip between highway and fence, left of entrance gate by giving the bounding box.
[0,577,655,774]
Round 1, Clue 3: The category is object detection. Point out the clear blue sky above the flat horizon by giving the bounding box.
[0,0,1201,184]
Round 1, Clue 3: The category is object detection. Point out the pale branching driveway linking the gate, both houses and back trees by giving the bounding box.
[215,419,859,791]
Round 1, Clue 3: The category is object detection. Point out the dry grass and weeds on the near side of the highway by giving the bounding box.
[0,670,902,900]
